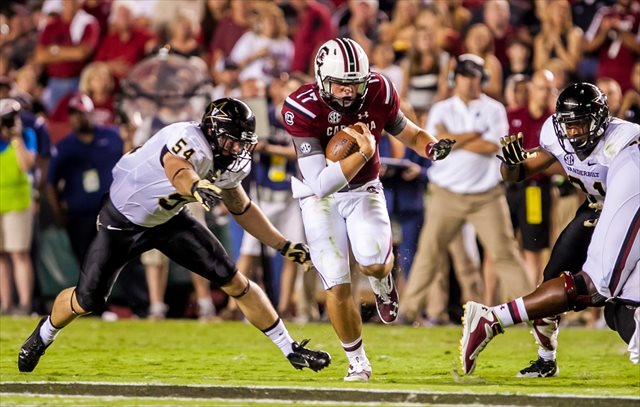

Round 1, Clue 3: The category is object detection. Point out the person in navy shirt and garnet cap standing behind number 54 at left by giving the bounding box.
[47,94,123,264]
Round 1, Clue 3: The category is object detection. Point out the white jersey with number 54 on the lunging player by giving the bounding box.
[109,122,251,227]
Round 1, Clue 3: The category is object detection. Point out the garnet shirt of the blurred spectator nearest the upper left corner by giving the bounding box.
[38,16,100,78]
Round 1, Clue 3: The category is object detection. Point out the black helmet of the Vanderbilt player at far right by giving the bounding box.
[553,82,611,161]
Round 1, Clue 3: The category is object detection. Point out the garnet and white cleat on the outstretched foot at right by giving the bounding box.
[460,301,504,374]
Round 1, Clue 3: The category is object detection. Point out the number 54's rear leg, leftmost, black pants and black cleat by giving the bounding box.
[18,203,145,372]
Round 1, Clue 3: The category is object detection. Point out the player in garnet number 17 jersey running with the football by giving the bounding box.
[282,38,453,381]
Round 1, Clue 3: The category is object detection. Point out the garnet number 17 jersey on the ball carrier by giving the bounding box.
[282,72,400,186]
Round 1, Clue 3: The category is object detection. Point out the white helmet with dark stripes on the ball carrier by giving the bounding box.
[314,38,370,114]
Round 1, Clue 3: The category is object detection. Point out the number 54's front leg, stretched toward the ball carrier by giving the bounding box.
[154,211,331,371]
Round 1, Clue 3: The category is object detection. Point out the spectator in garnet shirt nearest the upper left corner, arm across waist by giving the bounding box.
[35,0,100,112]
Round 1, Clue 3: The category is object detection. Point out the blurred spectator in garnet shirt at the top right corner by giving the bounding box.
[584,0,640,92]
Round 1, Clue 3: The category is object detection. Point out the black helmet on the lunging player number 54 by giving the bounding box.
[200,98,258,172]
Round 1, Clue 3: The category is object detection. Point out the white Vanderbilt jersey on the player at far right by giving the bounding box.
[540,116,640,202]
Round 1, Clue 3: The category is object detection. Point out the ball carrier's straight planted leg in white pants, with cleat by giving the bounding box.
[300,193,364,381]
